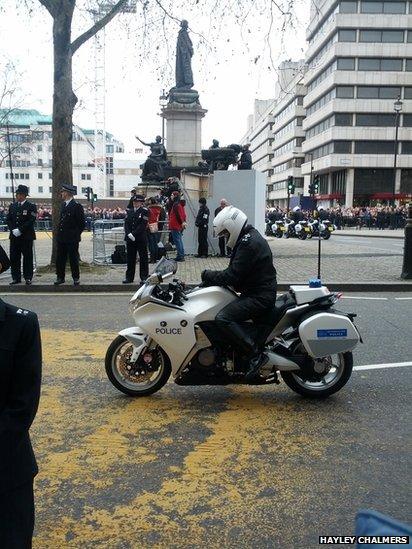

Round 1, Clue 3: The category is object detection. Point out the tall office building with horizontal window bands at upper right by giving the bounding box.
[302,0,412,206]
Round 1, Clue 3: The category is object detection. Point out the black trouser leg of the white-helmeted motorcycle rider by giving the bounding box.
[216,290,276,359]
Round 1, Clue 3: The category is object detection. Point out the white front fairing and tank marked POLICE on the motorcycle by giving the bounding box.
[130,286,237,377]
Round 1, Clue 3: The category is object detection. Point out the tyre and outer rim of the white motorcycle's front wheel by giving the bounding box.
[105,336,172,397]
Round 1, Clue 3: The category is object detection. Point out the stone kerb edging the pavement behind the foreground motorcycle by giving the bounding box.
[0,281,412,295]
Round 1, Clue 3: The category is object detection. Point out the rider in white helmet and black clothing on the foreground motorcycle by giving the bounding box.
[202,206,277,379]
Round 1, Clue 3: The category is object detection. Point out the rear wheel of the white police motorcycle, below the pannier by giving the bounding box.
[281,352,353,399]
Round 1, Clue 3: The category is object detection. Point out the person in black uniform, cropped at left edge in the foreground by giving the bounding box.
[0,249,42,549]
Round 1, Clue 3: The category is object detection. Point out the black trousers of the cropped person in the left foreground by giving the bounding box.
[0,480,34,549]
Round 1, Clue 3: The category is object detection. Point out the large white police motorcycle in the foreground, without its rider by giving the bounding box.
[105,258,360,398]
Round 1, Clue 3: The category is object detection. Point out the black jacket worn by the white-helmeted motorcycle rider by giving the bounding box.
[202,225,277,297]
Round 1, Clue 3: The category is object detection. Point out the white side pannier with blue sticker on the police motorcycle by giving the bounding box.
[299,312,359,358]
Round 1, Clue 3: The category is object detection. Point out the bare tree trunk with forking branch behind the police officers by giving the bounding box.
[34,0,128,263]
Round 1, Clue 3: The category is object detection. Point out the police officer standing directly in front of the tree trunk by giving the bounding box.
[54,184,86,286]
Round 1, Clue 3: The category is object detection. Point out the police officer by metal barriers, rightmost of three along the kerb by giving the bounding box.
[123,194,149,284]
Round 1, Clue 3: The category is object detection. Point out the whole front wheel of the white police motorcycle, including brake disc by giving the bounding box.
[105,336,172,397]
